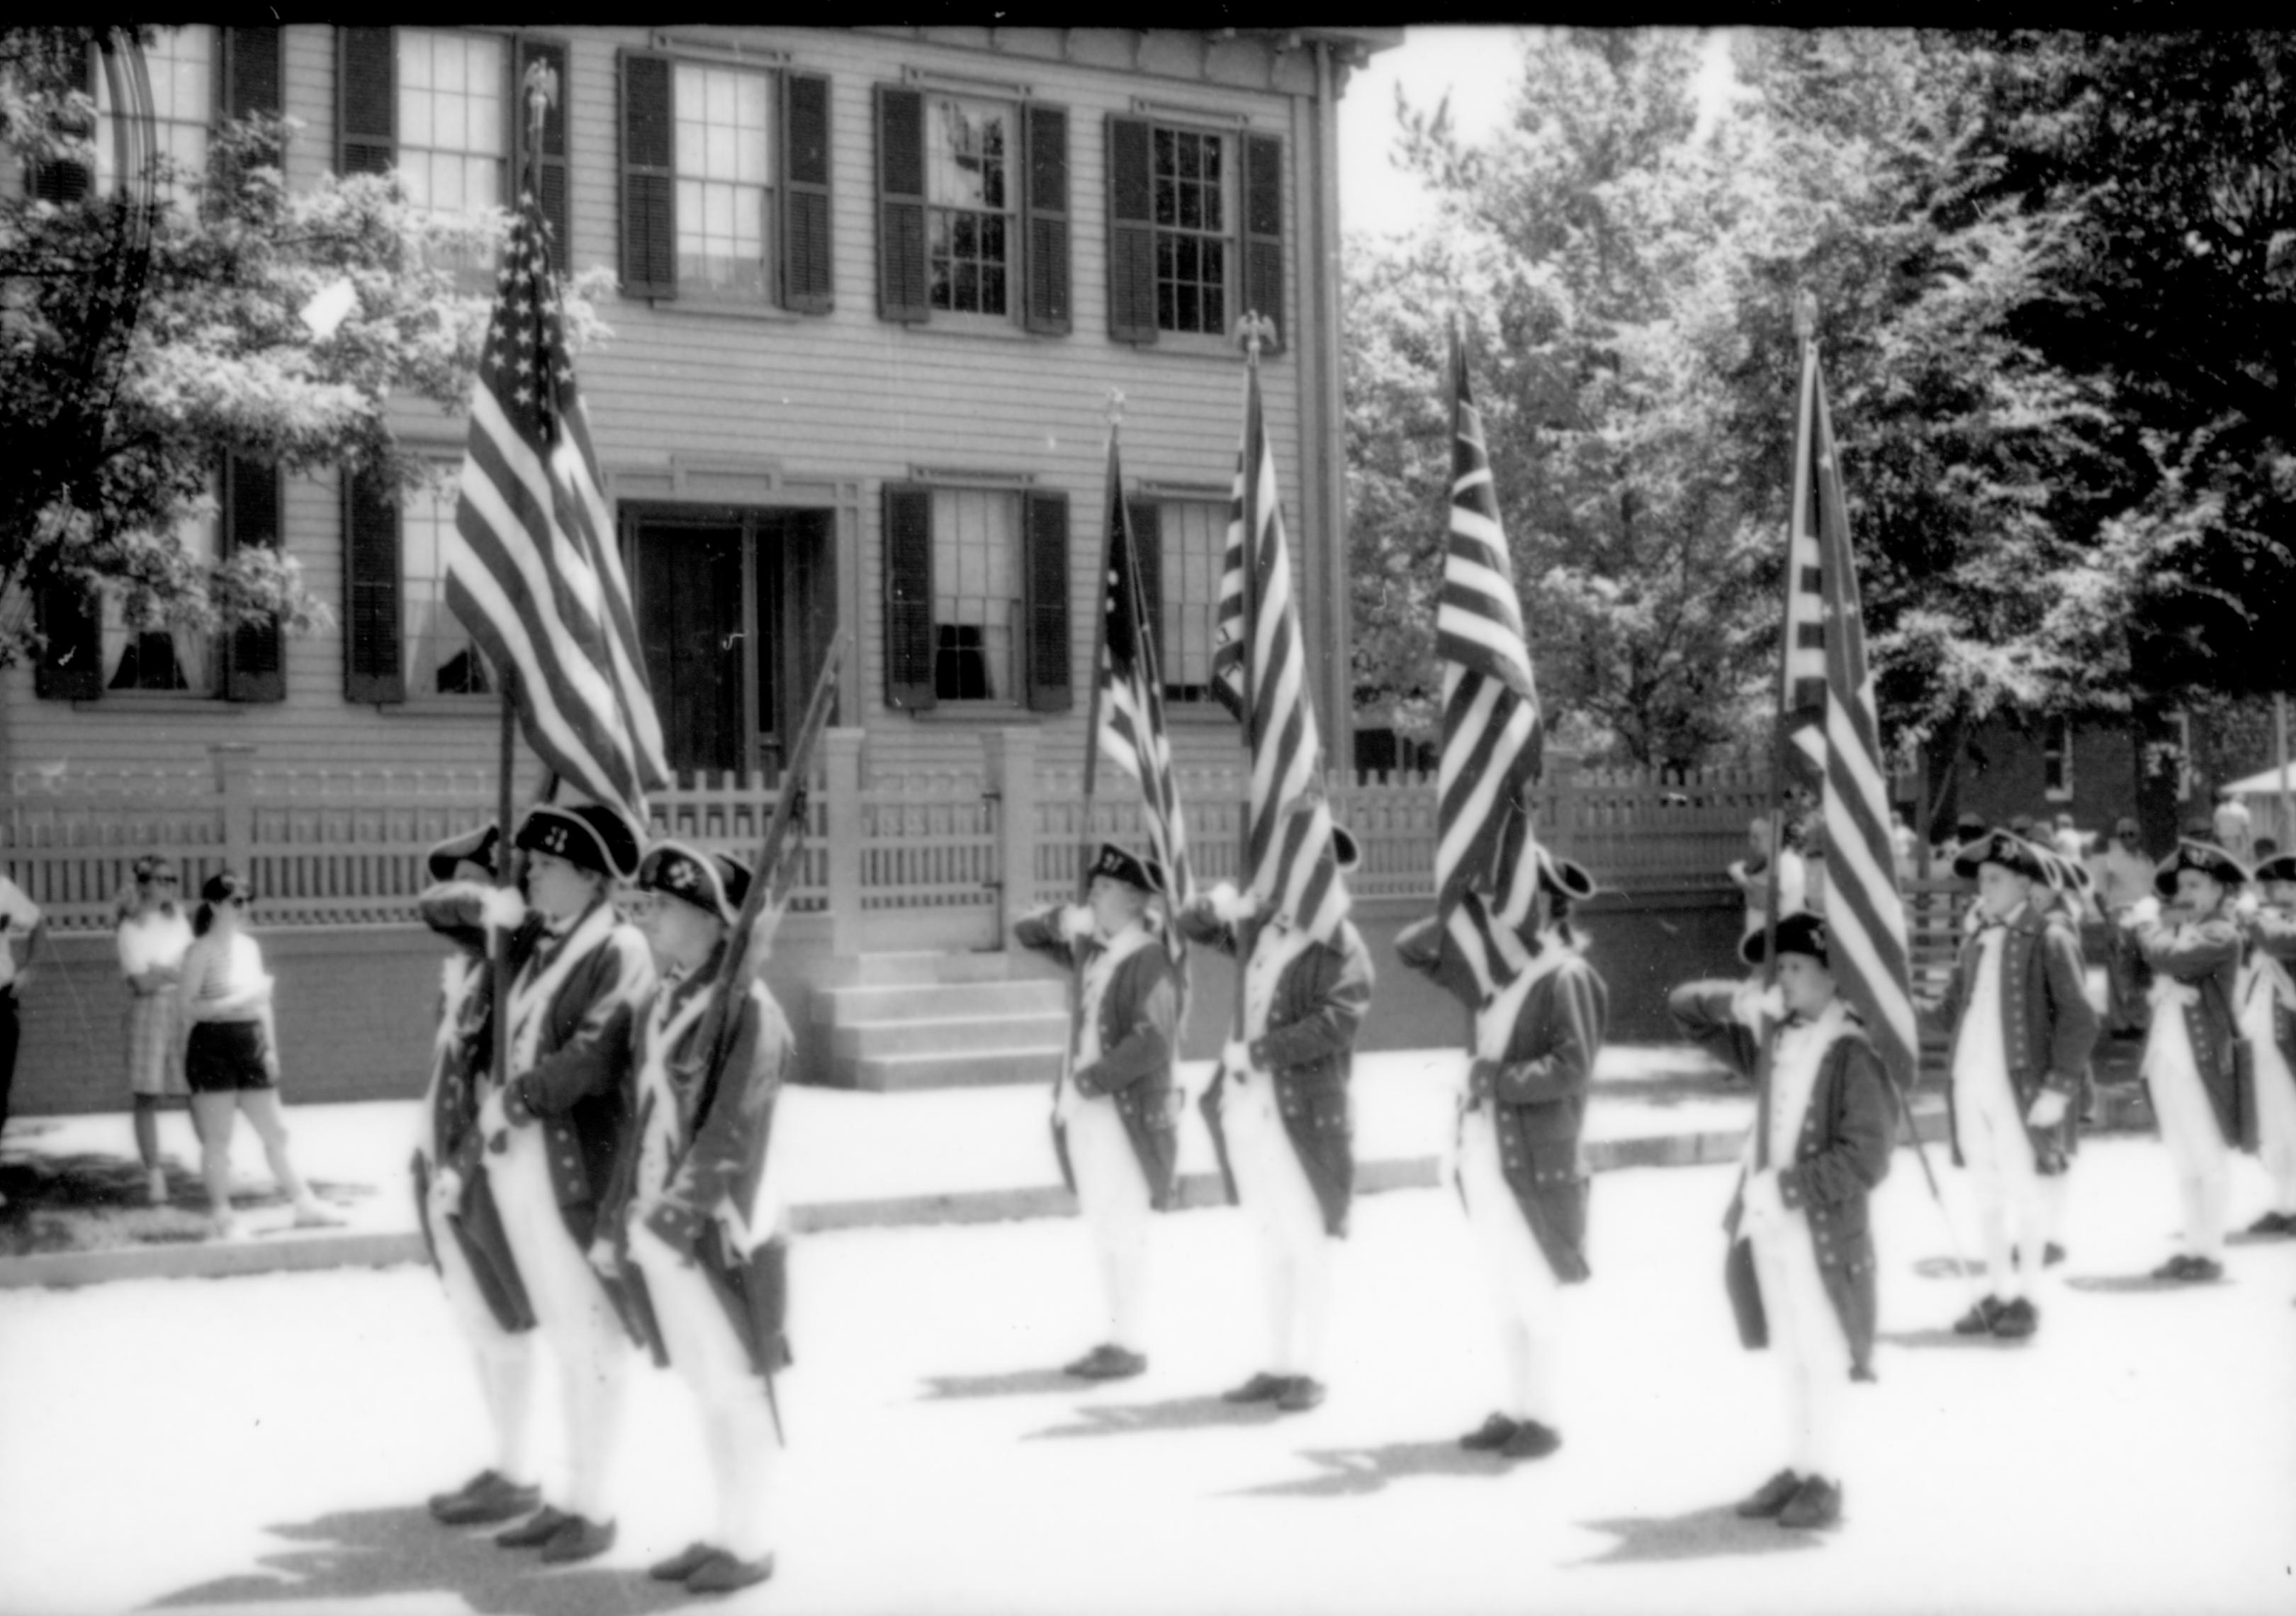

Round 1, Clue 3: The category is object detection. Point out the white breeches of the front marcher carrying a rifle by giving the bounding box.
[629,1221,781,1561]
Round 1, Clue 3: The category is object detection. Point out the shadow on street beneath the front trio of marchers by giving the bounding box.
[147,1508,693,1616]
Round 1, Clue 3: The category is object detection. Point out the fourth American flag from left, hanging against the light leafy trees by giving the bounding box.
[1435,337,1541,930]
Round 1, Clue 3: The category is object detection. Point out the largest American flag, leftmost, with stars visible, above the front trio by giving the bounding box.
[446,186,670,826]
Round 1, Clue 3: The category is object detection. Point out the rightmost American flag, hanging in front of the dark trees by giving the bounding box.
[1784,342,1920,1088]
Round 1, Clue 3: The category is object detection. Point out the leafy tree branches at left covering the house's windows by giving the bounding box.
[0,28,597,663]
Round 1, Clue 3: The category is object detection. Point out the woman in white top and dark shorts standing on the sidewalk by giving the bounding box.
[176,870,340,1240]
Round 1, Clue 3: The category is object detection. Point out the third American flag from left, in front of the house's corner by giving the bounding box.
[1212,353,1350,941]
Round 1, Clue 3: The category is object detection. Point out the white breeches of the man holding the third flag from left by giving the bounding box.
[1219,1072,1336,1377]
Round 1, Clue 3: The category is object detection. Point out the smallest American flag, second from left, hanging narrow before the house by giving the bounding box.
[1095,436,1192,962]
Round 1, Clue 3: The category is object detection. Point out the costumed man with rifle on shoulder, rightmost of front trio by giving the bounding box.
[592,840,794,1593]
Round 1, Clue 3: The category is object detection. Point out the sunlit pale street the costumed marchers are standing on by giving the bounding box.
[0,1138,2296,1616]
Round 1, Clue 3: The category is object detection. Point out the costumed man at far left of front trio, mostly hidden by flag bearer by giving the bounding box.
[413,824,542,1527]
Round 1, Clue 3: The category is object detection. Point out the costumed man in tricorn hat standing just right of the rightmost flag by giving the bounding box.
[1938,831,2096,1340]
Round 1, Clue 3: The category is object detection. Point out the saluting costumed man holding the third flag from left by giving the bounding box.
[1178,824,1371,1414]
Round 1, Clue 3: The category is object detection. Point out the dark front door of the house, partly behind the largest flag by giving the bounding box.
[622,507,835,780]
